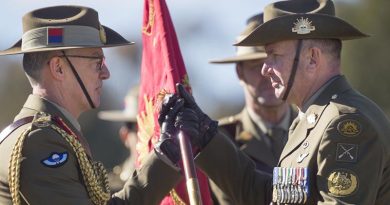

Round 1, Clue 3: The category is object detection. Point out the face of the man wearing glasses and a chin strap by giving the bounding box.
[66,48,110,109]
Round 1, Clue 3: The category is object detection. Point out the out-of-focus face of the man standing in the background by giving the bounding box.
[237,60,283,107]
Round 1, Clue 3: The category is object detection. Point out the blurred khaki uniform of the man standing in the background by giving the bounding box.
[210,107,297,204]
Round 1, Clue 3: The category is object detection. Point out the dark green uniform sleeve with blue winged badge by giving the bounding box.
[20,128,92,205]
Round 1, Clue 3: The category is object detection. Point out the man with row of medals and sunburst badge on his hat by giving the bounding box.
[158,0,390,205]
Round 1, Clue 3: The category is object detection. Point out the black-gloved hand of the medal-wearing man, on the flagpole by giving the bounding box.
[175,84,218,153]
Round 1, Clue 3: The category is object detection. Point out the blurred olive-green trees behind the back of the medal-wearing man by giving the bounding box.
[336,0,390,116]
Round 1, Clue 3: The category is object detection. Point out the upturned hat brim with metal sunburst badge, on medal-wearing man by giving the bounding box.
[235,14,368,46]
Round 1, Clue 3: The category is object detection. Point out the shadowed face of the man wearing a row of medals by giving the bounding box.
[261,40,299,102]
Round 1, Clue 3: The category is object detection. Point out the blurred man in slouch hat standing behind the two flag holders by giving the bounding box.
[210,13,296,204]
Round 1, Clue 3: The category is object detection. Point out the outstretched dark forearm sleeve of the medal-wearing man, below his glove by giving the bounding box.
[196,133,272,205]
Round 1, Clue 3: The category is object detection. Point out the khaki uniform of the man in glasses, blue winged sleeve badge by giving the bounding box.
[0,95,178,205]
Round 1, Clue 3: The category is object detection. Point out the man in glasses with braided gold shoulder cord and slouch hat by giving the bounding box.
[0,6,179,205]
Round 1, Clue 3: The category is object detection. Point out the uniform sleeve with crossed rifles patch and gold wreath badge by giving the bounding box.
[316,113,385,205]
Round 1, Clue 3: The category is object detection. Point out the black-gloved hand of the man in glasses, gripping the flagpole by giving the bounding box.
[155,94,184,164]
